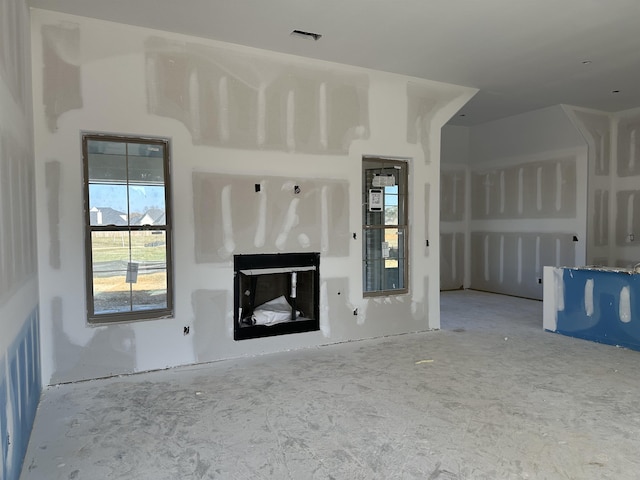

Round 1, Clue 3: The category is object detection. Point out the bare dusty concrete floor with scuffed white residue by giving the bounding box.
[21,291,640,480]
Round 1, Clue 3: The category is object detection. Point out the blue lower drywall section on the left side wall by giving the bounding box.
[0,308,42,480]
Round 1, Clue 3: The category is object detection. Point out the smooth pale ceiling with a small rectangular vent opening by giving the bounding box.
[28,0,640,125]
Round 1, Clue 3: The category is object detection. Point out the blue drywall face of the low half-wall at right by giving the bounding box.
[556,269,640,350]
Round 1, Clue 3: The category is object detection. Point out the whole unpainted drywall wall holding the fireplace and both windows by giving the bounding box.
[32,9,475,383]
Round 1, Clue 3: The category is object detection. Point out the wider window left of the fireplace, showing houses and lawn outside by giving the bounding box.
[82,134,173,323]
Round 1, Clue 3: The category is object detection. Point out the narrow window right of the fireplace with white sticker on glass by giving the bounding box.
[362,157,409,296]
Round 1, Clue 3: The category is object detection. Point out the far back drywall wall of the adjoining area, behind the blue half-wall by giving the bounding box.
[462,106,588,299]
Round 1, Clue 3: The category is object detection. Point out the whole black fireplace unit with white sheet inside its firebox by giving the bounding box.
[233,252,320,340]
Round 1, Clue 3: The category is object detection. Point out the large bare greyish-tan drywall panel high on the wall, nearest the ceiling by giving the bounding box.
[145,37,369,154]
